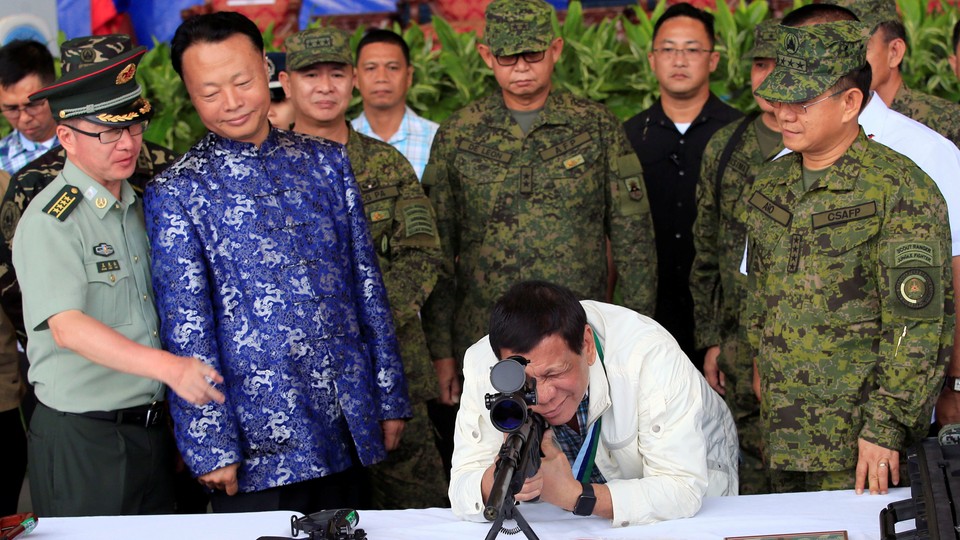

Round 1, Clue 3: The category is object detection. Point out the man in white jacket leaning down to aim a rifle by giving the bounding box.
[449,281,738,526]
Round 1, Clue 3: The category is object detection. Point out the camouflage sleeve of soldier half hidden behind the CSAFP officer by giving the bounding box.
[690,129,730,348]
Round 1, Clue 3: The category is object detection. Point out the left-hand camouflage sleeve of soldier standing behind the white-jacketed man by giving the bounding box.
[421,124,458,360]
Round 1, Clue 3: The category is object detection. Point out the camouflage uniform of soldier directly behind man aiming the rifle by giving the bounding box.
[423,90,657,358]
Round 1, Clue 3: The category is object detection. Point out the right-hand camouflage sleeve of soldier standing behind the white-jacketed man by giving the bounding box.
[612,115,657,317]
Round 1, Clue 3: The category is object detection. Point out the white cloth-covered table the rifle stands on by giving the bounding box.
[31,488,914,540]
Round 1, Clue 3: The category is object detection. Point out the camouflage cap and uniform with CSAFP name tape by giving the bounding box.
[738,22,953,490]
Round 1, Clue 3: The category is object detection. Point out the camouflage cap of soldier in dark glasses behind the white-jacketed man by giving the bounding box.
[484,0,555,56]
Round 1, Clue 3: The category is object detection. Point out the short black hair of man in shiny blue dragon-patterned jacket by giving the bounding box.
[170,11,263,79]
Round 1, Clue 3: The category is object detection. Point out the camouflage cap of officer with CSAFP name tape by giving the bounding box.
[756,21,867,103]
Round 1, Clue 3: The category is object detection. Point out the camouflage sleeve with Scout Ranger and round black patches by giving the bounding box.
[860,169,954,449]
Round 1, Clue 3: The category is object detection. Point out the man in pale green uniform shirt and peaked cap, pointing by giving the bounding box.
[13,34,224,516]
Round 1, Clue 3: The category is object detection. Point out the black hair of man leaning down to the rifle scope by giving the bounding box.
[490,281,587,358]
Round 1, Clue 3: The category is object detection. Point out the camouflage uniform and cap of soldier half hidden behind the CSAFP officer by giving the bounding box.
[690,20,783,495]
